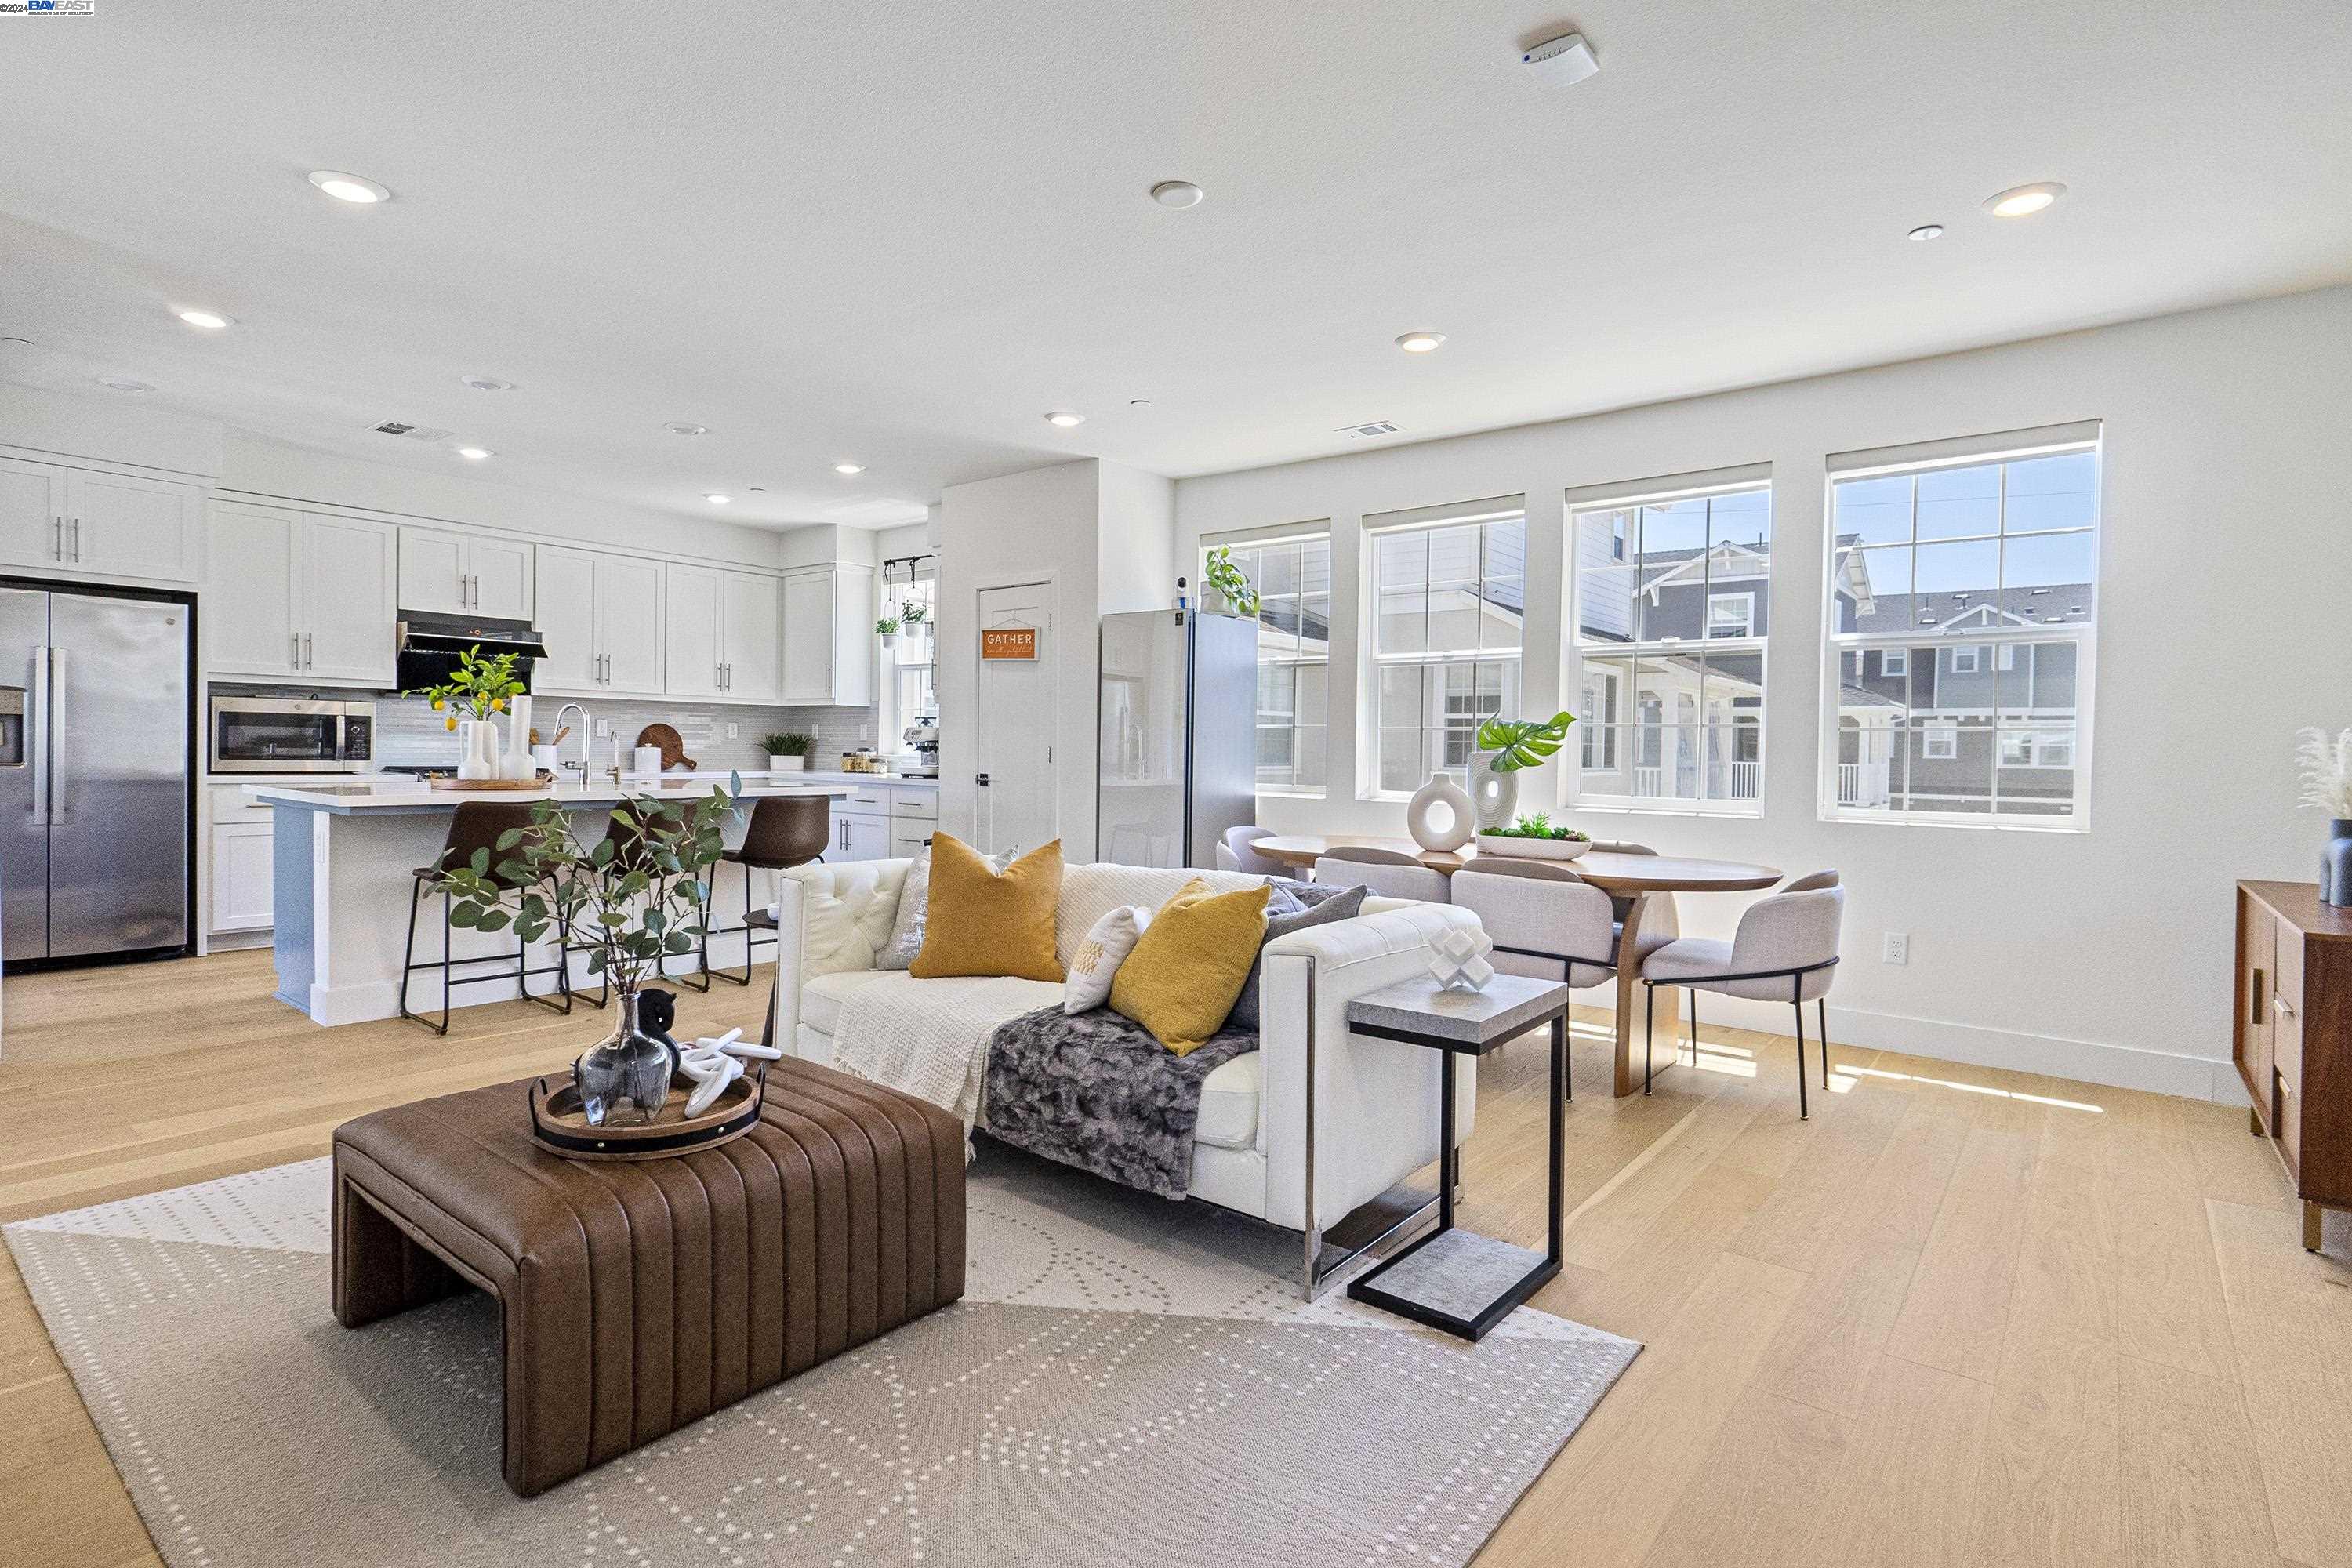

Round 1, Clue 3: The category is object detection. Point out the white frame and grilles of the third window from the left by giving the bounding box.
[1562,466,1778,818]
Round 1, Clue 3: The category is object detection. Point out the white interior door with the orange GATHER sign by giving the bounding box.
[974,583,1061,853]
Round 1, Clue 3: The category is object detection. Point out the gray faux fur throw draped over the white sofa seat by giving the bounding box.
[985,1006,1258,1199]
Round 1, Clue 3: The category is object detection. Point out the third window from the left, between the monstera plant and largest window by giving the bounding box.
[1569,485,1771,813]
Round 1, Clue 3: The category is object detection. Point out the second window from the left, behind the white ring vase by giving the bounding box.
[1364,496,1526,794]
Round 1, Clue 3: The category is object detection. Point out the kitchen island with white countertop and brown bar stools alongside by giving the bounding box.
[247,774,849,1025]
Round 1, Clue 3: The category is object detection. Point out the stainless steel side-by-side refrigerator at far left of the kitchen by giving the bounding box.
[0,586,195,964]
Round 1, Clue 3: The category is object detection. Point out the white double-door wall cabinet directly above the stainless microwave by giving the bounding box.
[202,501,397,687]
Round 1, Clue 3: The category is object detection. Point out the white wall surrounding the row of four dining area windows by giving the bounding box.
[1176,289,2352,1100]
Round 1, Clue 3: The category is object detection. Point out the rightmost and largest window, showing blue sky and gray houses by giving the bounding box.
[1823,426,2098,827]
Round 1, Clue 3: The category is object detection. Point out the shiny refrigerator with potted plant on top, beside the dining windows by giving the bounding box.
[1094,609,1258,867]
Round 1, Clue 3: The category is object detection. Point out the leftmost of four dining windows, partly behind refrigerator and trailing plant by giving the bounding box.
[1209,534,1331,794]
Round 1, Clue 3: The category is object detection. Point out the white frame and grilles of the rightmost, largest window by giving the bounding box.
[1818,421,2107,832]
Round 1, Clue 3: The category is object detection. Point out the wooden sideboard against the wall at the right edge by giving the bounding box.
[2232,881,2352,1253]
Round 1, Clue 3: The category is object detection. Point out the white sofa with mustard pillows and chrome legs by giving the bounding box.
[776,860,1477,1295]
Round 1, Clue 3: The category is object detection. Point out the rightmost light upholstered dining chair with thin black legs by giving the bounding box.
[1642,872,1846,1121]
